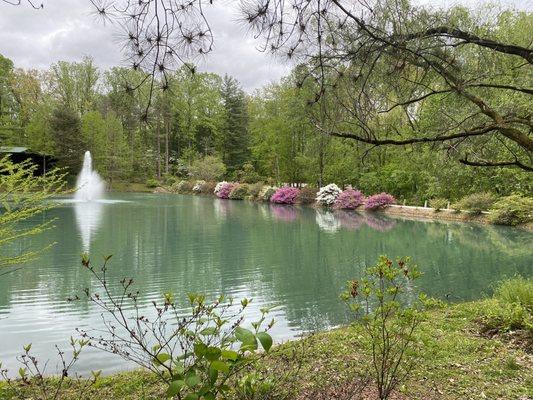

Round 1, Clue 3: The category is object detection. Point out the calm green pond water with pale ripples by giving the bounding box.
[0,194,533,372]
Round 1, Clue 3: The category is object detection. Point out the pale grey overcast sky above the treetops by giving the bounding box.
[0,0,533,91]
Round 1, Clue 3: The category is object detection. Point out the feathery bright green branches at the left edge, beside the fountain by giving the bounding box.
[0,157,65,267]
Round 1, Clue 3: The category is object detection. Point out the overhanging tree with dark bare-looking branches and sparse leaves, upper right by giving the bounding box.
[243,0,533,170]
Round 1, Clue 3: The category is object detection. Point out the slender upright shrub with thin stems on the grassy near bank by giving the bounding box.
[341,256,425,400]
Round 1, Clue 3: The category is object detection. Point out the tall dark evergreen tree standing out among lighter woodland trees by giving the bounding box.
[221,75,250,173]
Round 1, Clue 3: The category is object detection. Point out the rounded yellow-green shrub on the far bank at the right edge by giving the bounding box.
[490,194,533,226]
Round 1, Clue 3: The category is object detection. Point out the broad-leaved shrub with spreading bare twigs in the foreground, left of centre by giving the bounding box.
[76,255,274,400]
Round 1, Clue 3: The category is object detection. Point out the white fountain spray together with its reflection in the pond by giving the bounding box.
[74,151,105,251]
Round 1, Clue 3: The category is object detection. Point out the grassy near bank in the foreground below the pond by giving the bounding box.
[0,300,533,400]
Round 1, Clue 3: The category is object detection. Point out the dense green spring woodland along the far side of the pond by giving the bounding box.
[0,9,533,204]
